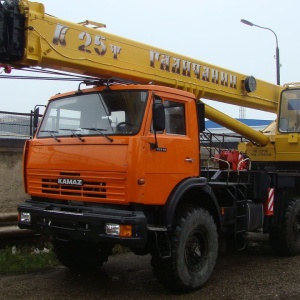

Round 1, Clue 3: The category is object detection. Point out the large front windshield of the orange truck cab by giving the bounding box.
[38,91,147,139]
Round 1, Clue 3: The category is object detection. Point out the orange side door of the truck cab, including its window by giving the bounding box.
[144,96,199,204]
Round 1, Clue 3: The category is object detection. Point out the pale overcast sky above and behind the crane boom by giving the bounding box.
[0,0,300,119]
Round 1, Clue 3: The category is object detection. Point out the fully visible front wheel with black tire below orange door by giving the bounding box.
[151,208,218,292]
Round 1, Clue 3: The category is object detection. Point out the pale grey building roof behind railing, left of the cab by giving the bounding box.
[0,111,31,139]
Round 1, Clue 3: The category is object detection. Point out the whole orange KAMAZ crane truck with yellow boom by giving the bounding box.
[0,0,300,291]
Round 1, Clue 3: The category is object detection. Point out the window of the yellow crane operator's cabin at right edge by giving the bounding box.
[278,89,300,132]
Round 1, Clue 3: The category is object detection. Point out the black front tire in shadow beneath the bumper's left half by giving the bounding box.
[52,238,113,271]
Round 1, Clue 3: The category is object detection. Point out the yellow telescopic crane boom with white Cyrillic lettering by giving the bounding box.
[0,0,281,113]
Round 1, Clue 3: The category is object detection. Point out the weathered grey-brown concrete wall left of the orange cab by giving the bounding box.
[0,143,28,214]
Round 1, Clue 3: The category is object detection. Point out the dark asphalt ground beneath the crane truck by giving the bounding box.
[0,235,300,300]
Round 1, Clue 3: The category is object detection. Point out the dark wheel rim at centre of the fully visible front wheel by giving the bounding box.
[185,228,208,272]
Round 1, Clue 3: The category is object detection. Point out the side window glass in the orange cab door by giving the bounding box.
[164,100,186,135]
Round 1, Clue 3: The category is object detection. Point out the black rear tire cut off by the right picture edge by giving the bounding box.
[270,197,300,256]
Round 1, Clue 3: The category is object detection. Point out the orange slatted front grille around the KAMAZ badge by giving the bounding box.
[28,170,125,202]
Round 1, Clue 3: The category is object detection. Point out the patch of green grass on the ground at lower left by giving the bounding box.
[0,247,59,275]
